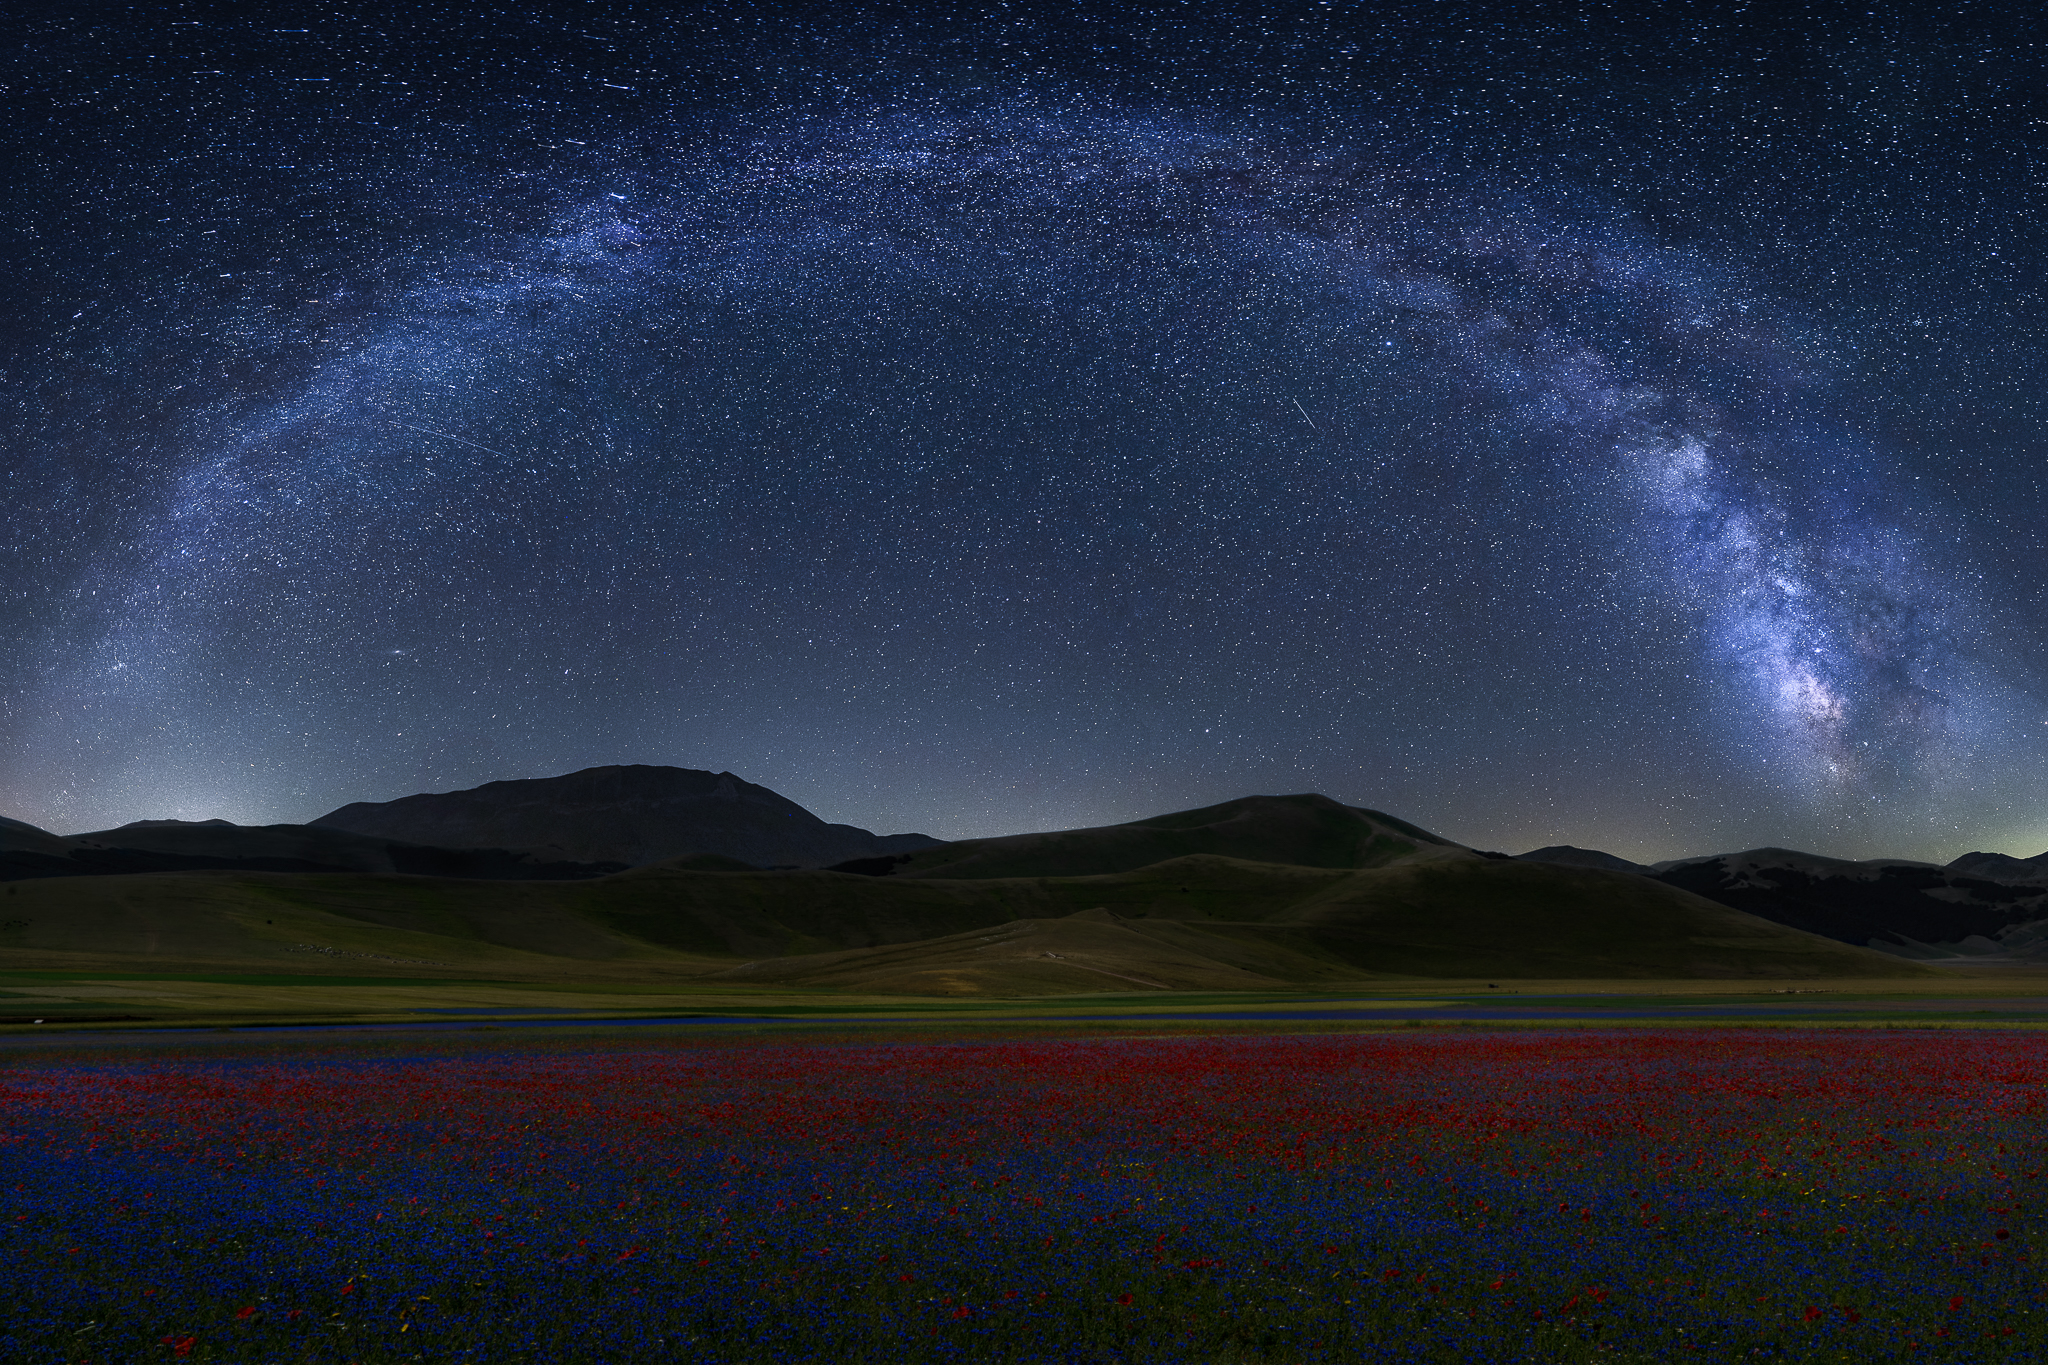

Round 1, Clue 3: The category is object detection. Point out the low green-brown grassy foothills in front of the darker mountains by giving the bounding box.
[0,847,1929,995]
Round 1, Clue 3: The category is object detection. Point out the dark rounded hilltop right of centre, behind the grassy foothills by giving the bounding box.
[836,796,1479,878]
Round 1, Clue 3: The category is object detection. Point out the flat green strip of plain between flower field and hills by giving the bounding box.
[19,968,2048,1035]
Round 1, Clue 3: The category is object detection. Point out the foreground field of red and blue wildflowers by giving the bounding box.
[0,1029,2048,1365]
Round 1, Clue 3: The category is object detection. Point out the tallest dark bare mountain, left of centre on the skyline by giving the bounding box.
[313,763,938,868]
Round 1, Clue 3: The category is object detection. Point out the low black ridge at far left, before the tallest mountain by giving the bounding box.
[0,821,625,882]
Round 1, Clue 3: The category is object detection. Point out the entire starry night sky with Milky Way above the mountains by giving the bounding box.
[0,0,2048,860]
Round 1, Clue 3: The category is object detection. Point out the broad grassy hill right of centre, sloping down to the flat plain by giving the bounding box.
[700,857,1923,995]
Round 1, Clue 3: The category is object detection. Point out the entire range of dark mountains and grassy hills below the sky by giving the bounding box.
[0,765,2048,995]
